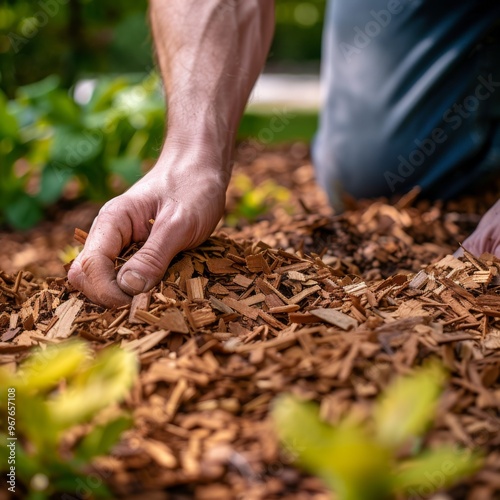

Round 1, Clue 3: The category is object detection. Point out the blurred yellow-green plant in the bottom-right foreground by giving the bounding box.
[272,364,482,500]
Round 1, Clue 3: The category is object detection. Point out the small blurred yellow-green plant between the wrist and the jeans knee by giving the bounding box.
[225,173,291,226]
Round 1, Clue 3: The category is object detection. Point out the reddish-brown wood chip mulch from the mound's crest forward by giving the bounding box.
[0,224,500,500]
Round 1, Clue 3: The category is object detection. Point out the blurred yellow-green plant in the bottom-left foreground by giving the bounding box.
[0,341,138,499]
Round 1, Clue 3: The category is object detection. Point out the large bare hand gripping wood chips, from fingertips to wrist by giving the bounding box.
[68,148,229,307]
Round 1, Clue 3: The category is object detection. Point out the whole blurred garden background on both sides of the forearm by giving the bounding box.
[0,0,325,229]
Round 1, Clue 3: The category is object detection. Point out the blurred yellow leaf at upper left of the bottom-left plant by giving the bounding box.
[16,341,90,393]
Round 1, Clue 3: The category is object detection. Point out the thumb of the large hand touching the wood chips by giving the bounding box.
[117,221,182,295]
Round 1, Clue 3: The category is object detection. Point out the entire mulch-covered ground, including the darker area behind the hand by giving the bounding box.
[0,144,500,500]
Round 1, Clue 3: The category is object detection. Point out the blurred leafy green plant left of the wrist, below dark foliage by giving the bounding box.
[0,73,165,229]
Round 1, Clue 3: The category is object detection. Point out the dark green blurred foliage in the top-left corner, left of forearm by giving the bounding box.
[0,0,153,97]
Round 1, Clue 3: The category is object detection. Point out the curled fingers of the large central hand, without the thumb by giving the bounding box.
[68,204,132,307]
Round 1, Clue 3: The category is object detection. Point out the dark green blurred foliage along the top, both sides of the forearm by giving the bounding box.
[0,0,326,94]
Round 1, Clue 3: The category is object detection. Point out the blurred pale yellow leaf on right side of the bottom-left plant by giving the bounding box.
[49,347,138,425]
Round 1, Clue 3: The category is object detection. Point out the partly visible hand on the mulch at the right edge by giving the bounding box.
[455,200,500,257]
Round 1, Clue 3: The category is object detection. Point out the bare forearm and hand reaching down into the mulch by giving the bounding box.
[68,0,274,307]
